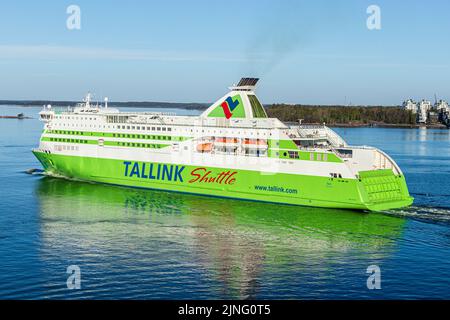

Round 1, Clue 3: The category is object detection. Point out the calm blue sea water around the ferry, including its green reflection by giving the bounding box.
[0,106,450,299]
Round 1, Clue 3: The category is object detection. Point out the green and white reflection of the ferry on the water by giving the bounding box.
[36,177,405,298]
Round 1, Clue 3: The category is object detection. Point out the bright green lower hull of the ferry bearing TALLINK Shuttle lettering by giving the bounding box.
[33,150,412,211]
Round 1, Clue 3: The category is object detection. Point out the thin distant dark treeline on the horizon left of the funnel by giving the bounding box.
[0,100,209,110]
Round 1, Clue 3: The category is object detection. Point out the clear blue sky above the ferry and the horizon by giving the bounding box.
[0,0,450,104]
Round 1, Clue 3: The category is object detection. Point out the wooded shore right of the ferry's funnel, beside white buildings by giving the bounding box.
[266,104,416,124]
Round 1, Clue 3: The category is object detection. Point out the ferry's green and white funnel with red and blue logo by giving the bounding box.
[201,78,267,119]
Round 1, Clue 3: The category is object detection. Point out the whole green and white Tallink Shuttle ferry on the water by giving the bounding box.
[33,78,413,211]
